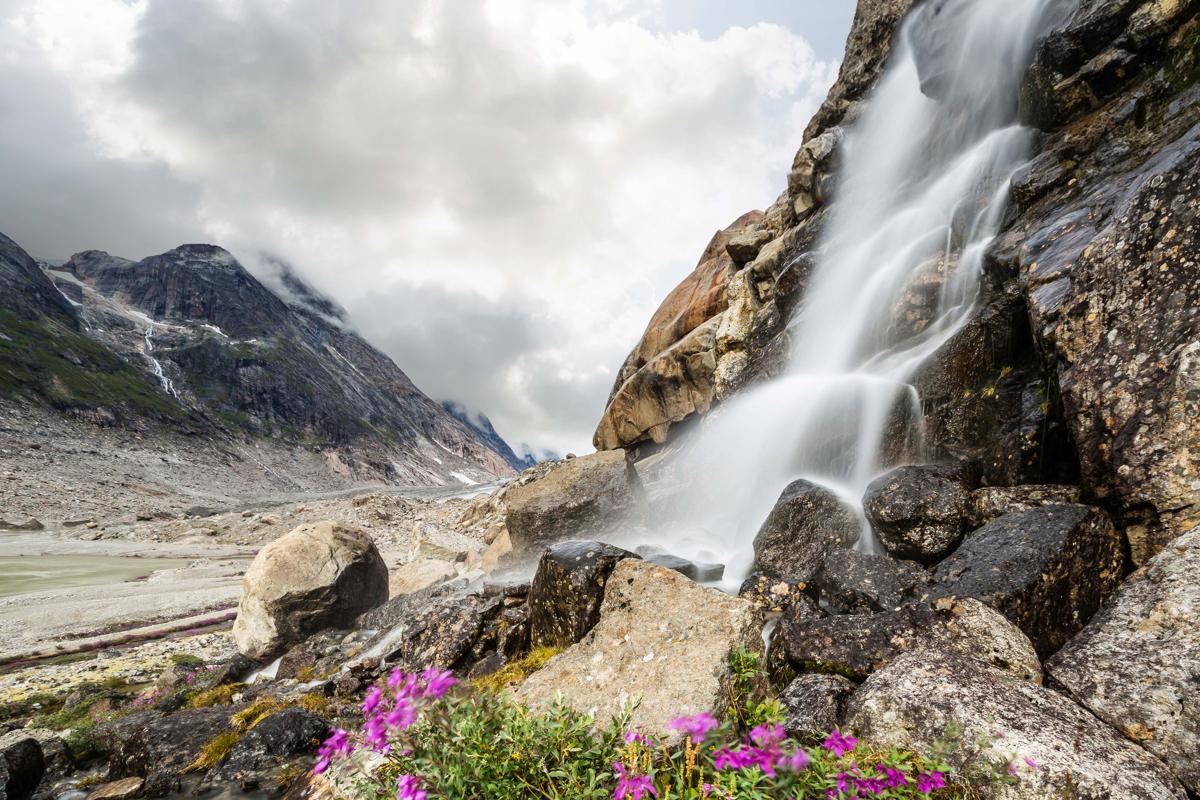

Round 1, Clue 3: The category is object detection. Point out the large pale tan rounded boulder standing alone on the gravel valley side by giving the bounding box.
[233,522,388,658]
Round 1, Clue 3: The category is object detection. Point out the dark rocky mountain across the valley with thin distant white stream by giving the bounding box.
[0,231,514,485]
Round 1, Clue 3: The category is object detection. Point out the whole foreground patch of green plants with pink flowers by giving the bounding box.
[313,669,1037,800]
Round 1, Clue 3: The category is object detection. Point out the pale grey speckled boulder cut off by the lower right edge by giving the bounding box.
[1046,531,1200,793]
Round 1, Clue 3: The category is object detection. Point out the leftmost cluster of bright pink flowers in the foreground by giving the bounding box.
[312,668,458,786]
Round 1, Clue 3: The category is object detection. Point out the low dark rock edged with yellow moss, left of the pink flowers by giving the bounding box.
[206,709,329,788]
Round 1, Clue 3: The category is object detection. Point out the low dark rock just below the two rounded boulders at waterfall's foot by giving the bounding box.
[816,551,931,614]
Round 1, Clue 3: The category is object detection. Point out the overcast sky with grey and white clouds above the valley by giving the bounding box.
[0,0,854,452]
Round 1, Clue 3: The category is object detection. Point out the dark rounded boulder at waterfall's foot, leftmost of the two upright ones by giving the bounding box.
[754,480,862,583]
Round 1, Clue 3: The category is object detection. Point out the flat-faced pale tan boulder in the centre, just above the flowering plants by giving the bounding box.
[516,559,762,735]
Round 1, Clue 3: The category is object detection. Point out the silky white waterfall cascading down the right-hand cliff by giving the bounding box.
[638,0,1073,585]
